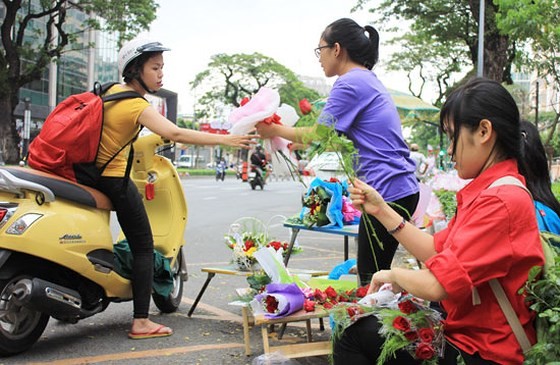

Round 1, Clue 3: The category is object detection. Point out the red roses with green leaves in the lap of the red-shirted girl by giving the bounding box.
[375,293,445,365]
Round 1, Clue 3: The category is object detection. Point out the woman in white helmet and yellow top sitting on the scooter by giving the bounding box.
[95,39,257,339]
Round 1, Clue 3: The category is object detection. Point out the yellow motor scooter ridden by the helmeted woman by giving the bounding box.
[0,134,187,356]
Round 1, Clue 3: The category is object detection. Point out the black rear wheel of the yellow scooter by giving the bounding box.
[0,276,49,356]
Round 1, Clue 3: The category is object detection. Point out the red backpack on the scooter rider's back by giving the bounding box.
[27,82,142,186]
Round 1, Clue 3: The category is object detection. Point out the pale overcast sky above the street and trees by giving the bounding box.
[143,0,406,113]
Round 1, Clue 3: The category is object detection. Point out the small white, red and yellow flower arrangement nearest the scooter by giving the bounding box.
[225,232,266,270]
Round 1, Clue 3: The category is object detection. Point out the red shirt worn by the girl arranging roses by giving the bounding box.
[426,160,544,365]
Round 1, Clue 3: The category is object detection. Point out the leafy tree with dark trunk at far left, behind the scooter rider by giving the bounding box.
[0,0,157,162]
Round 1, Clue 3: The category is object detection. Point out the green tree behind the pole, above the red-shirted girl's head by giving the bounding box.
[356,0,516,99]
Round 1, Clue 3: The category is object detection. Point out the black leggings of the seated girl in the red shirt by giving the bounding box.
[333,316,496,365]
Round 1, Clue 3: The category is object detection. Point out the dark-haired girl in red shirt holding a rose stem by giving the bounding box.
[333,78,544,365]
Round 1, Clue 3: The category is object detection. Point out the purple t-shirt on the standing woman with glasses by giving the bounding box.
[319,68,419,201]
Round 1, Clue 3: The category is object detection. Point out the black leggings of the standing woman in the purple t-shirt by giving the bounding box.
[358,193,420,286]
